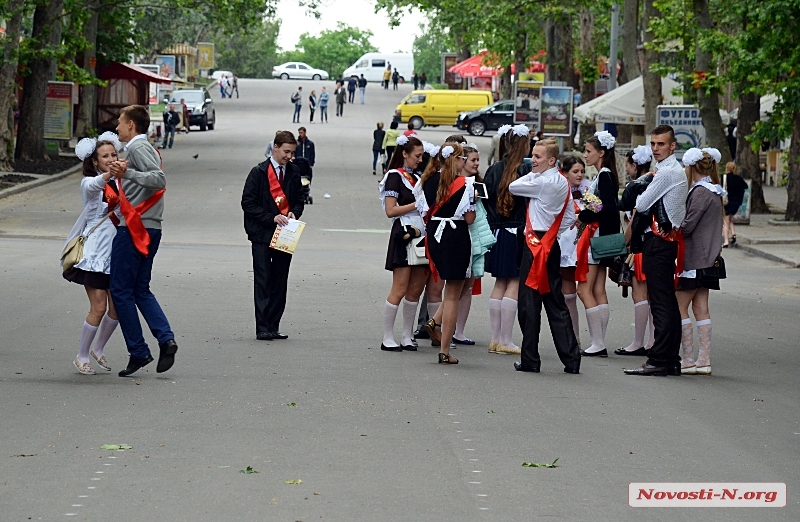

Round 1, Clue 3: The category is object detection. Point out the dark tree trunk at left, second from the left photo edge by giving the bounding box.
[16,0,64,160]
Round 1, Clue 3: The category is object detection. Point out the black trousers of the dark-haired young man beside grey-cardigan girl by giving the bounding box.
[642,234,681,366]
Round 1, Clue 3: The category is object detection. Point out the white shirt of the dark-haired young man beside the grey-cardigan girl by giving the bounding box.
[636,154,688,229]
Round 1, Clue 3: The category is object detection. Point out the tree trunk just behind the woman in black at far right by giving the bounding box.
[736,93,769,214]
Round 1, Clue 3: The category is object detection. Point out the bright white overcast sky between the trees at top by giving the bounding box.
[278,0,425,53]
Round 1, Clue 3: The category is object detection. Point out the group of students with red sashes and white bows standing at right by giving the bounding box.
[380,125,728,375]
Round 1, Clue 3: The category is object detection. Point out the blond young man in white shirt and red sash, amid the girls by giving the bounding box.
[509,138,580,374]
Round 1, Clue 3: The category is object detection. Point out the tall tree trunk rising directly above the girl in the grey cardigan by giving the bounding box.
[694,0,731,169]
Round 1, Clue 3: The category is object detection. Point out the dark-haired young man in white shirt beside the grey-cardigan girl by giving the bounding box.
[625,125,688,375]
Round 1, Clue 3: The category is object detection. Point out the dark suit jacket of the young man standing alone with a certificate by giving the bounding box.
[242,159,304,243]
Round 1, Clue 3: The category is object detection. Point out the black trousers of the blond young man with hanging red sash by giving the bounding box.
[518,238,581,369]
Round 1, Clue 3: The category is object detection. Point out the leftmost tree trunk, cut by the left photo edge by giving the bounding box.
[0,0,25,171]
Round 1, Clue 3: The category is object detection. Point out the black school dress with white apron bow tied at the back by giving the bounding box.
[422,172,472,281]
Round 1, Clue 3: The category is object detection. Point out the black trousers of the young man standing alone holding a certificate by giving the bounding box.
[252,243,292,334]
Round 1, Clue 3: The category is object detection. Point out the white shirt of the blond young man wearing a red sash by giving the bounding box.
[508,167,575,236]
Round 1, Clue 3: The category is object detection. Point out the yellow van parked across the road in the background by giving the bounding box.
[394,89,494,129]
